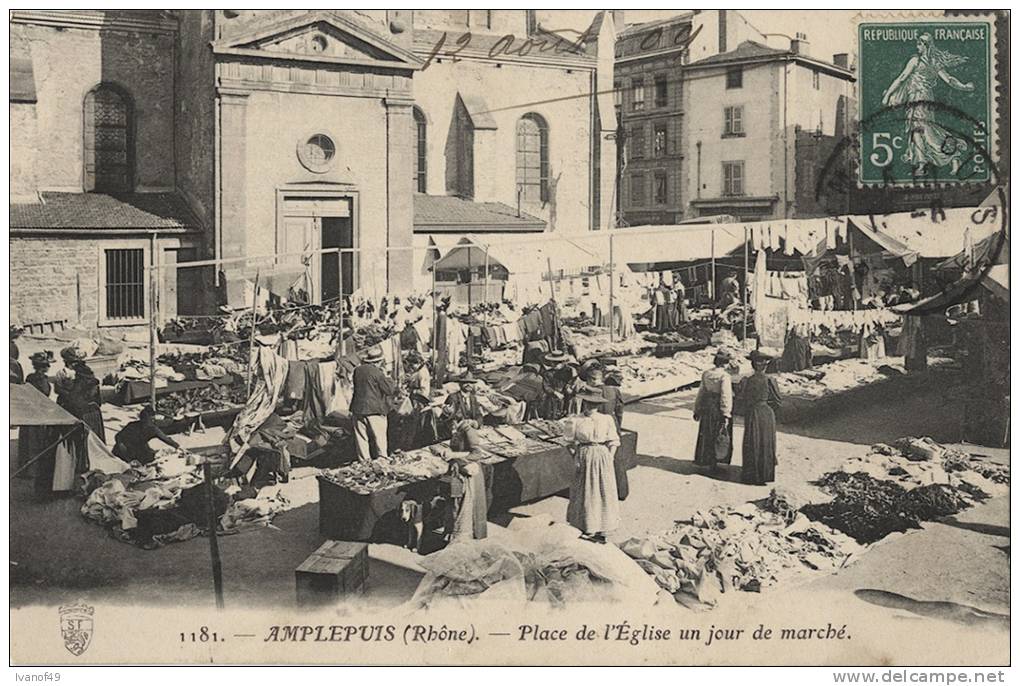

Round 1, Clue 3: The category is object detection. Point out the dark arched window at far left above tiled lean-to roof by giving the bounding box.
[83,84,133,193]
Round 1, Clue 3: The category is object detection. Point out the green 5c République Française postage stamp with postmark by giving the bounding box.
[857,17,995,186]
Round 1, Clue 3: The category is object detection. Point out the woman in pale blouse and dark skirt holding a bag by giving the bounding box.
[695,351,733,467]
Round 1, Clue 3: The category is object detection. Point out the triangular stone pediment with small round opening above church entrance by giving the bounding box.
[213,11,422,69]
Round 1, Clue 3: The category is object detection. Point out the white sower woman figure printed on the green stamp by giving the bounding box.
[882,34,974,176]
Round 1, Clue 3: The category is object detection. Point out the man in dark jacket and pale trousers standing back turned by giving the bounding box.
[351,346,395,462]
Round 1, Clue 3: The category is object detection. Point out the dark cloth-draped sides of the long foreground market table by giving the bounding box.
[318,429,638,544]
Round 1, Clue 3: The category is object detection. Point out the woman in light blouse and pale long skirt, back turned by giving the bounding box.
[567,391,620,543]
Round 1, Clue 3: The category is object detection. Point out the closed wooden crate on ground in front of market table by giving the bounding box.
[294,540,368,605]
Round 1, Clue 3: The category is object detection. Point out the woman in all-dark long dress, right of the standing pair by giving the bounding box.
[741,351,779,486]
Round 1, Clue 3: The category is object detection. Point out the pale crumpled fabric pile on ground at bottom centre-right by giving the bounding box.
[621,503,860,608]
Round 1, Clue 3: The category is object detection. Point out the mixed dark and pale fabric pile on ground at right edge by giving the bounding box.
[801,437,1010,543]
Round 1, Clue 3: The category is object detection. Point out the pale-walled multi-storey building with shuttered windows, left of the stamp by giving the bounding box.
[681,35,854,219]
